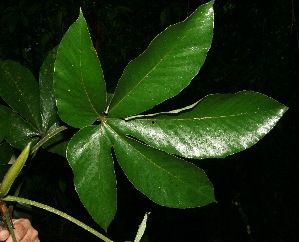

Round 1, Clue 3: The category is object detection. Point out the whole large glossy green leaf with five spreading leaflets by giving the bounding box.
[54,1,287,232]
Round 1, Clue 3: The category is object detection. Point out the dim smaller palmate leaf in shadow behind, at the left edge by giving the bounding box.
[0,48,65,152]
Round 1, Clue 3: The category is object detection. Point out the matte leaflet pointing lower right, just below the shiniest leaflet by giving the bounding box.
[109,130,215,208]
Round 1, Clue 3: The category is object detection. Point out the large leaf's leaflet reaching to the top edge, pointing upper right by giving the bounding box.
[108,1,214,118]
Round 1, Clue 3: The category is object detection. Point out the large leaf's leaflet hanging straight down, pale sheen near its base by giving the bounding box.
[67,126,116,230]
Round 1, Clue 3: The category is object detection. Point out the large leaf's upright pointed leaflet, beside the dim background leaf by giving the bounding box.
[54,9,106,128]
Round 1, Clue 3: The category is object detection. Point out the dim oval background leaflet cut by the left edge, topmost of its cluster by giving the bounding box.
[0,60,42,132]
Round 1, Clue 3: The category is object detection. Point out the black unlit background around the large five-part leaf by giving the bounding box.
[0,0,299,242]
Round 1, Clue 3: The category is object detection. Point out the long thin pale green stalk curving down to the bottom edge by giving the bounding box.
[2,196,112,242]
